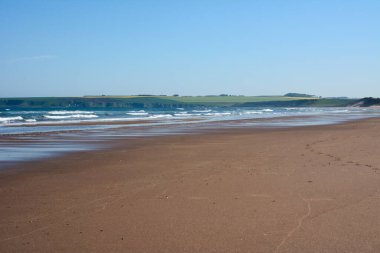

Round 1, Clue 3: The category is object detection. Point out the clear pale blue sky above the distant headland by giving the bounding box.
[0,0,380,97]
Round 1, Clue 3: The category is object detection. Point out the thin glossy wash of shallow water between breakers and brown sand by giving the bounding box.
[0,115,378,170]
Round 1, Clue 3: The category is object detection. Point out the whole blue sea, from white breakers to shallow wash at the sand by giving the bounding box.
[0,107,380,169]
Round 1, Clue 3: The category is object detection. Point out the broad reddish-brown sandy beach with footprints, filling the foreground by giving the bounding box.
[0,119,380,253]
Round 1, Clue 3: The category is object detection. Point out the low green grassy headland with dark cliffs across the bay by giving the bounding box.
[0,95,357,108]
